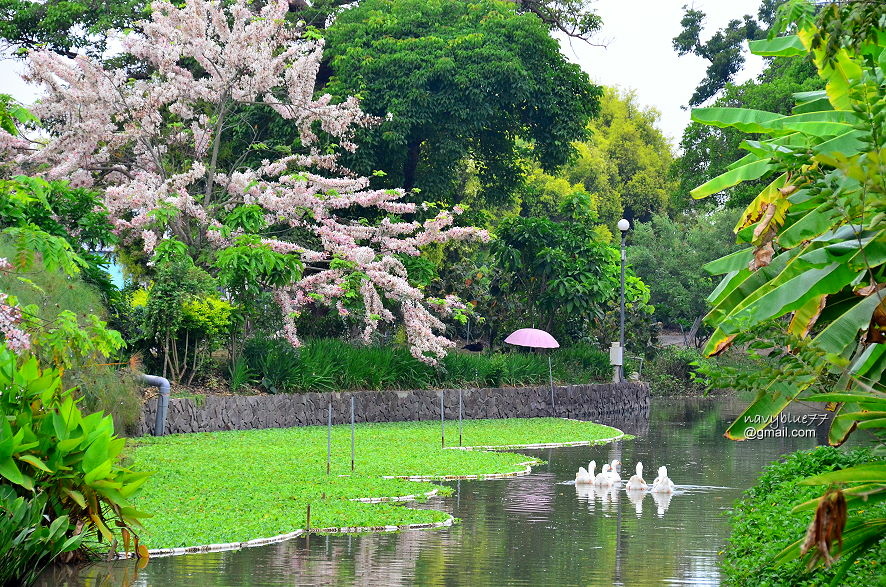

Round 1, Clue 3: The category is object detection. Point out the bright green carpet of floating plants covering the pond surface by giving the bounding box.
[131,418,617,548]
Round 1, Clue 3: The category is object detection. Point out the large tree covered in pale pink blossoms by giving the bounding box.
[21,0,488,362]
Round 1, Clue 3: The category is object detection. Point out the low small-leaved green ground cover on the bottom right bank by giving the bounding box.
[721,446,886,587]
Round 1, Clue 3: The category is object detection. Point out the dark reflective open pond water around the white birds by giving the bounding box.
[42,398,827,586]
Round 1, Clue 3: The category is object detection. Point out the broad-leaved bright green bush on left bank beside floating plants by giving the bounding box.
[0,345,150,556]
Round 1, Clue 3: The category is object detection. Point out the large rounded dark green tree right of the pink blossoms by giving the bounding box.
[327,0,600,202]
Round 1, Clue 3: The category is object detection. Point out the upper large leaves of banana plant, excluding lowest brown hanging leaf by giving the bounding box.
[692,23,886,445]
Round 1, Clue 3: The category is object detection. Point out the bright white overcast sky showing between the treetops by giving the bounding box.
[0,0,763,146]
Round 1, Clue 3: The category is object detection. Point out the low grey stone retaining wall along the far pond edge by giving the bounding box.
[137,383,649,435]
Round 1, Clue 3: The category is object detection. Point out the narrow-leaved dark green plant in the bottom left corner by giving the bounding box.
[0,485,83,585]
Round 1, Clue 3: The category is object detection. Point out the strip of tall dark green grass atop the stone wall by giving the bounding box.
[244,338,610,393]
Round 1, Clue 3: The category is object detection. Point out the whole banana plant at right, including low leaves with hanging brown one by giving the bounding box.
[692,7,886,584]
